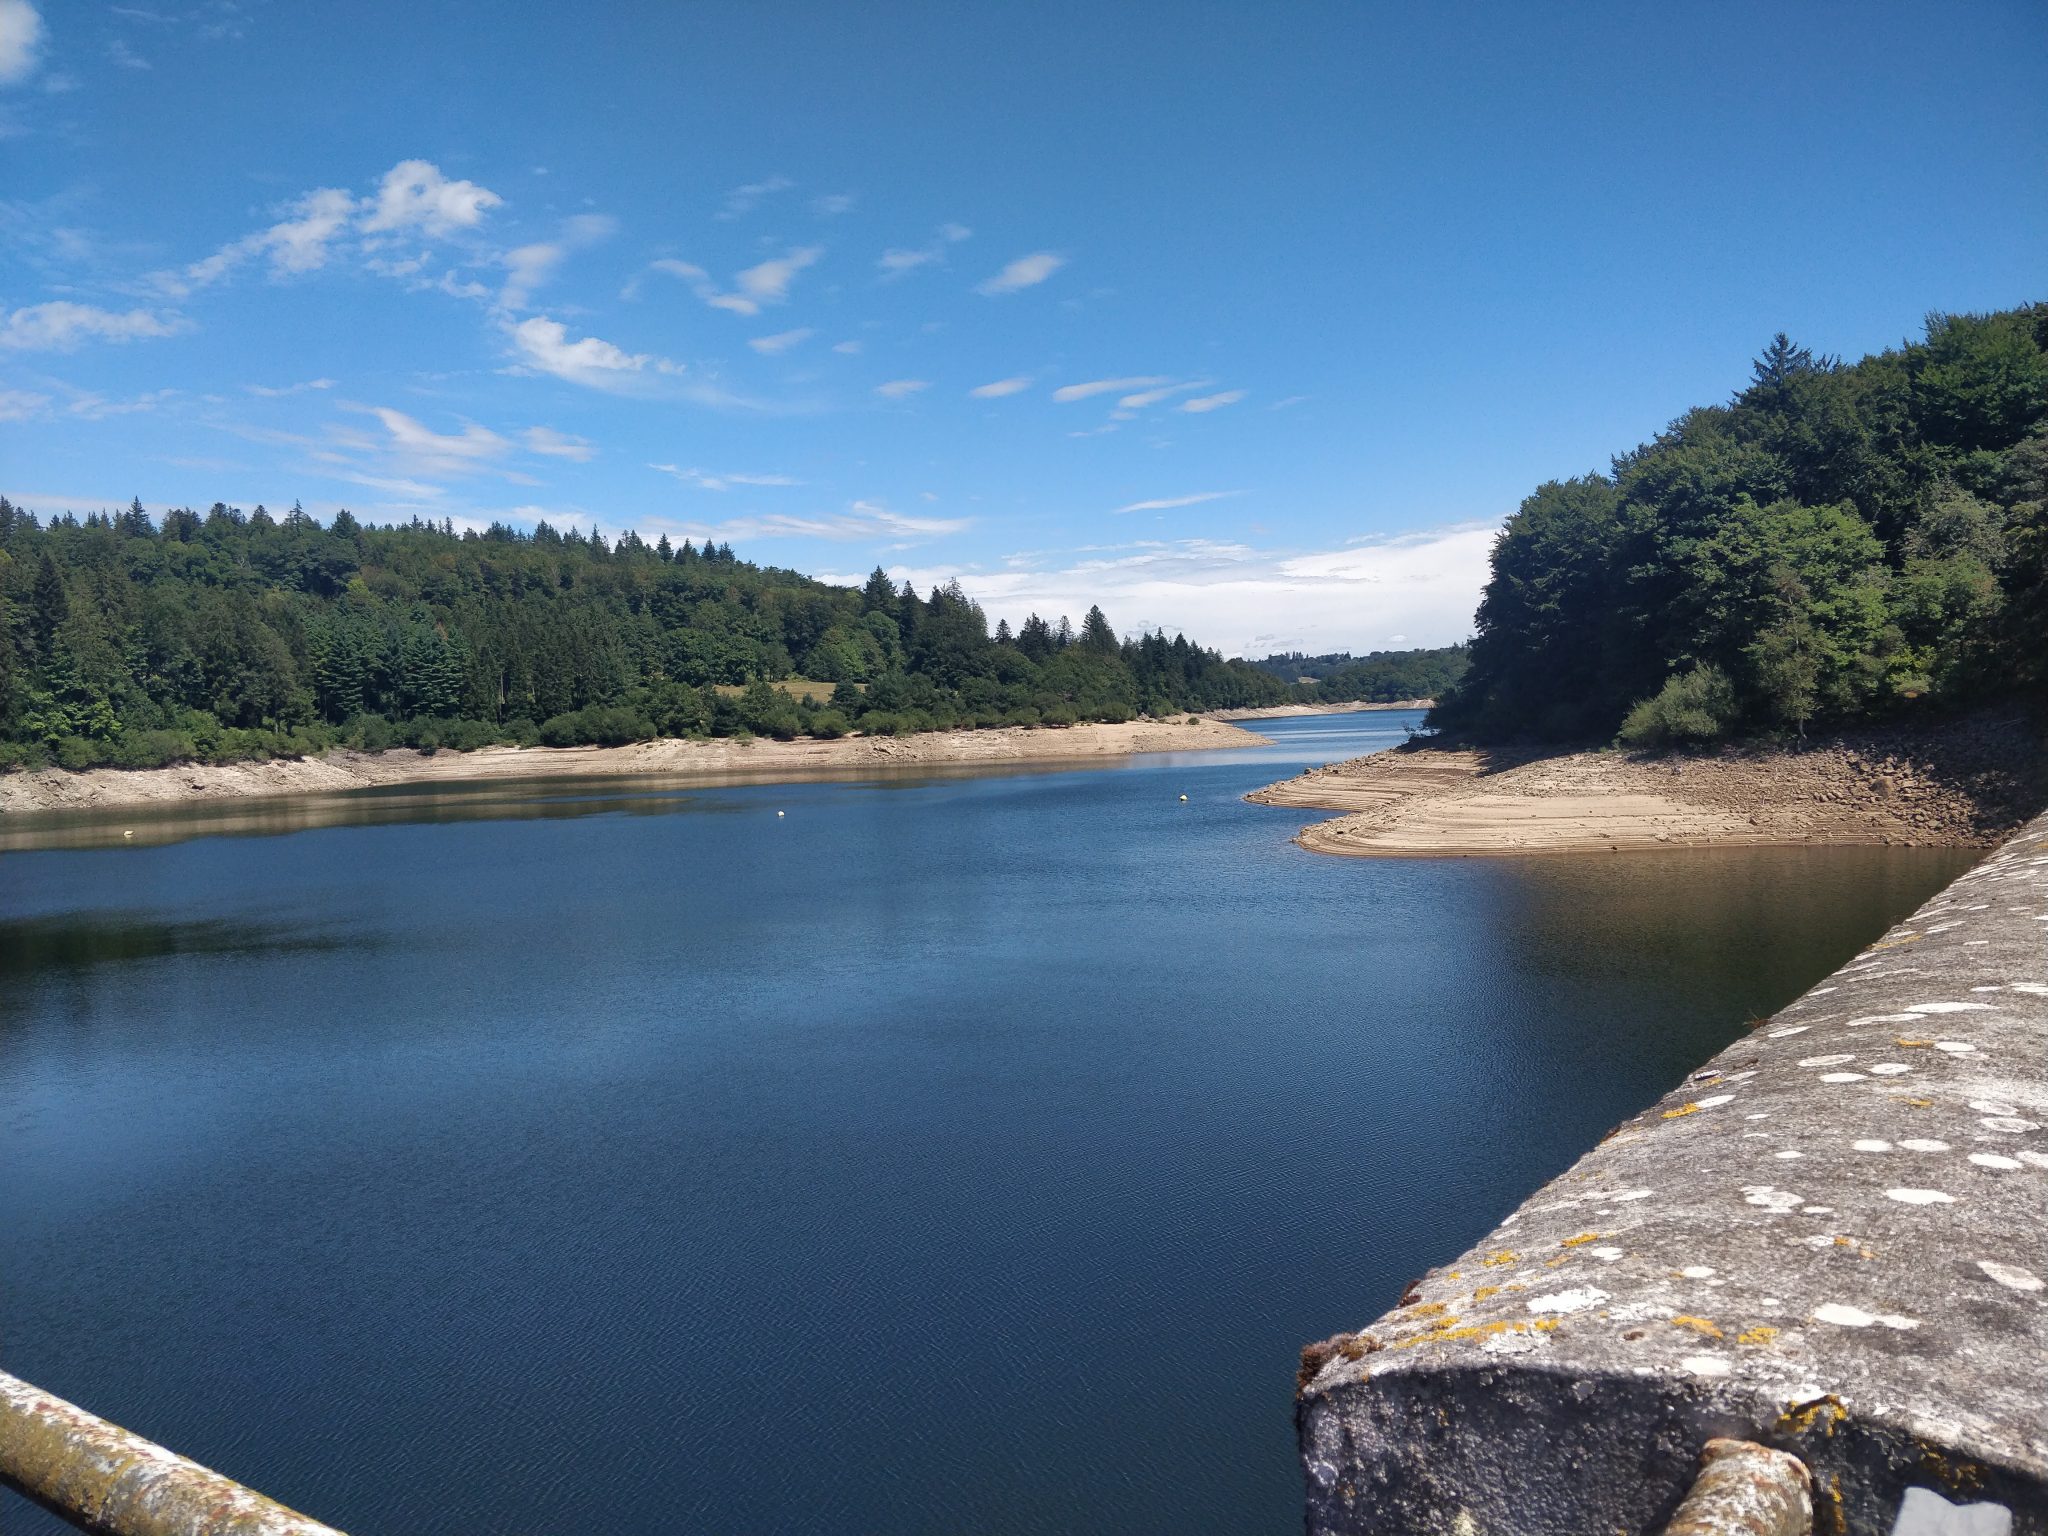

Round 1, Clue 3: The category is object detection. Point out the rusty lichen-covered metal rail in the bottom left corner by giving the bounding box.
[0,1372,340,1536]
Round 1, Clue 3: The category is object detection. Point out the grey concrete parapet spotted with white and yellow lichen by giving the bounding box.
[1296,817,2048,1536]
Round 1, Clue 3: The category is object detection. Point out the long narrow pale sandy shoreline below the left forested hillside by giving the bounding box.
[0,719,1266,815]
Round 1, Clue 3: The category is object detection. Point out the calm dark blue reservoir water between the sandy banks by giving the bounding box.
[0,713,1970,1536]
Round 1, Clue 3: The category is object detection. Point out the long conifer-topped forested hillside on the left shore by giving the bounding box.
[0,498,1286,768]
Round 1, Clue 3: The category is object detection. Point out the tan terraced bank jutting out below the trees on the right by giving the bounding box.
[1249,717,2048,856]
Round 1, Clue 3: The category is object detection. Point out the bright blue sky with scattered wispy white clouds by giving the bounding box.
[0,0,2048,653]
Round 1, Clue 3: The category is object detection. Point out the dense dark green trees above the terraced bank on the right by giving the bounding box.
[1430,305,2048,745]
